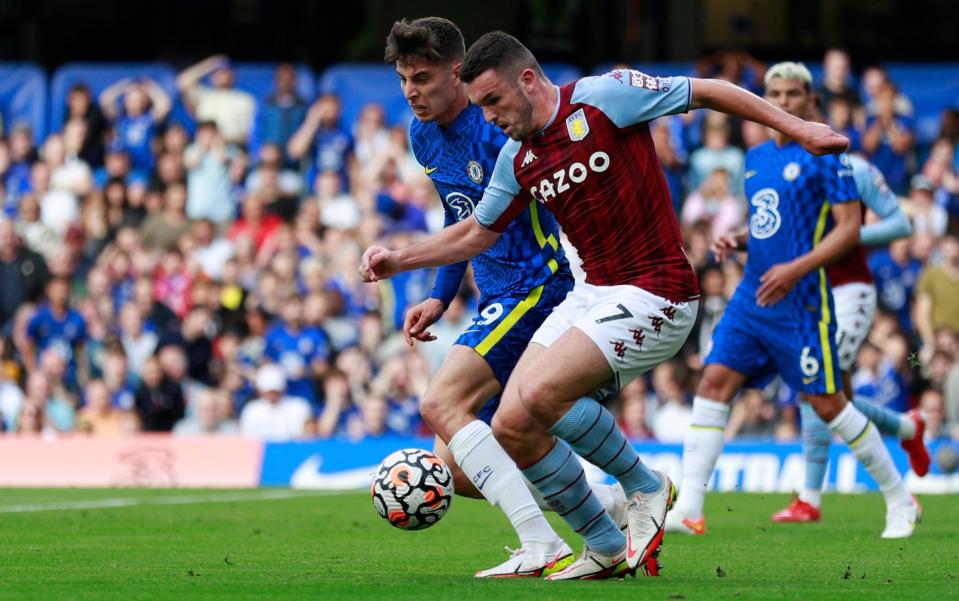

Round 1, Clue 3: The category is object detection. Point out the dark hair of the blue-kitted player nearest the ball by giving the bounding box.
[383,17,466,64]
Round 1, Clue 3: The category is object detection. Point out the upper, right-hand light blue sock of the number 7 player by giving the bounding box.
[550,397,662,497]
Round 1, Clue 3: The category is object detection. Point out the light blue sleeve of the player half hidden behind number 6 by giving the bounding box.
[849,156,912,246]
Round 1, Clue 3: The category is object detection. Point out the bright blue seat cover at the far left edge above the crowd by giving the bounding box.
[0,63,47,141]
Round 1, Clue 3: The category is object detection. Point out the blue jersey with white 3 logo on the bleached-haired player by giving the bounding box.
[733,141,859,321]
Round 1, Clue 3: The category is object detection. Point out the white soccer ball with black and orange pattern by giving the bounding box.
[370,449,453,530]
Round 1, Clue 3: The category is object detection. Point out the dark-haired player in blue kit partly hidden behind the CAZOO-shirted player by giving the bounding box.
[385,17,626,577]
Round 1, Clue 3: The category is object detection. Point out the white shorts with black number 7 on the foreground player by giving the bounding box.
[530,282,699,390]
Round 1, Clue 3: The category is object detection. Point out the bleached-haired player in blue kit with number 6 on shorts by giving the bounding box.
[666,63,919,538]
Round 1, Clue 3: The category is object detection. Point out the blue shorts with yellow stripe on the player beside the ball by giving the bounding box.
[455,272,574,423]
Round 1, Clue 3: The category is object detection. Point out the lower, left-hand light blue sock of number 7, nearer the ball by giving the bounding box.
[523,439,626,555]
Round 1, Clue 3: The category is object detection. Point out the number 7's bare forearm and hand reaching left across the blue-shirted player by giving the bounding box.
[359,218,499,282]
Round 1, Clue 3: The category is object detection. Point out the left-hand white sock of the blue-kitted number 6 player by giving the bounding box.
[676,396,729,520]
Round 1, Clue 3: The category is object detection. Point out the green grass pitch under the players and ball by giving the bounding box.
[0,489,959,601]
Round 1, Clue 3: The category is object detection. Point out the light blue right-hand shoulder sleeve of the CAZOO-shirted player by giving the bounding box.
[571,69,693,128]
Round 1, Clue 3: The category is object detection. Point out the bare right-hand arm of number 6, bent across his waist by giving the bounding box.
[756,202,861,307]
